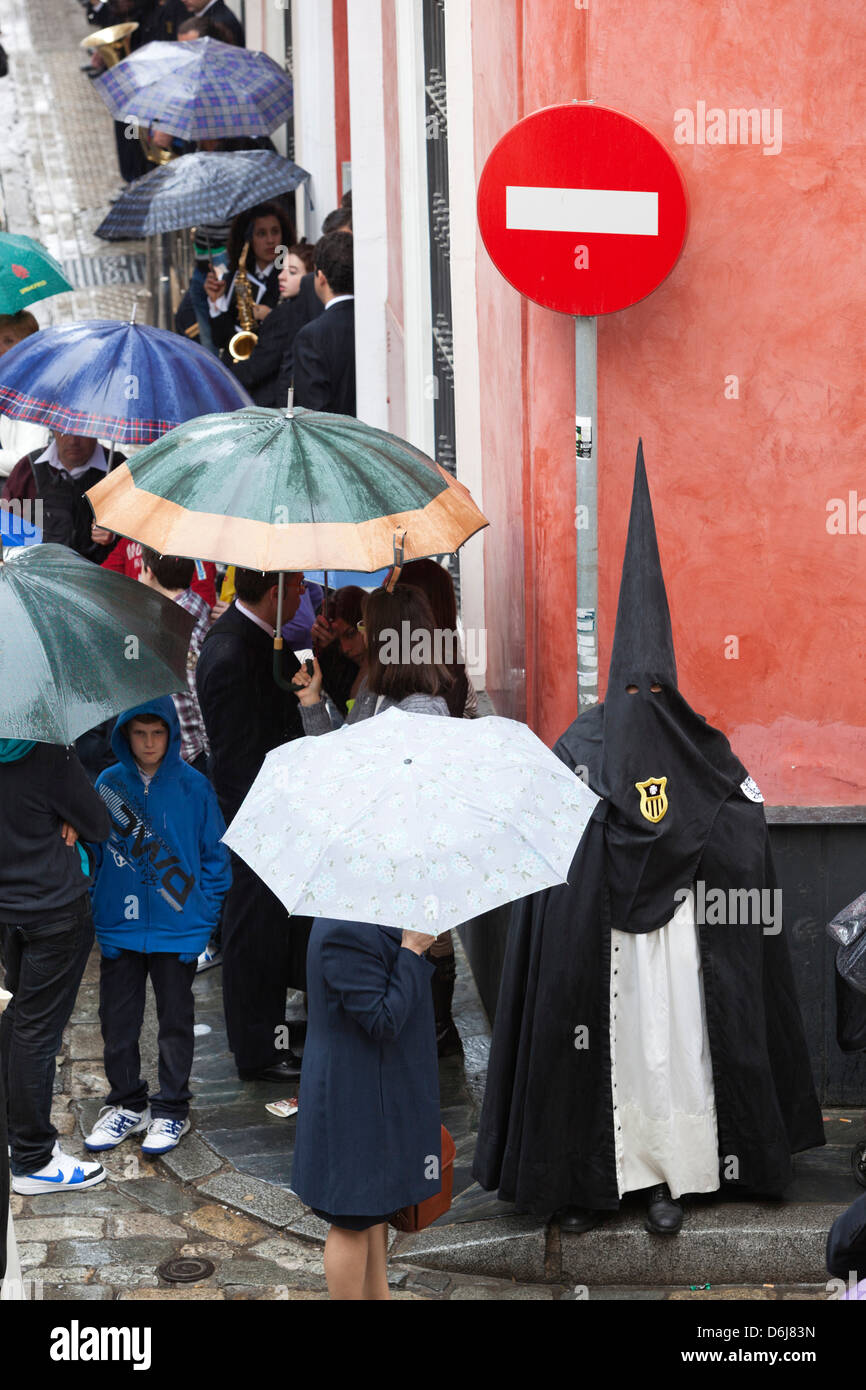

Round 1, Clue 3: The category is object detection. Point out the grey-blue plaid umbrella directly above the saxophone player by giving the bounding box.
[96,150,310,242]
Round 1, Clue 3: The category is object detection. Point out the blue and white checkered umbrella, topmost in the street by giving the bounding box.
[93,39,292,140]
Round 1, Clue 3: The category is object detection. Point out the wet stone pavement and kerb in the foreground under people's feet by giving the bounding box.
[13,934,862,1301]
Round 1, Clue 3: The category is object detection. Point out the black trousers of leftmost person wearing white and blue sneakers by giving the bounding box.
[0,892,93,1177]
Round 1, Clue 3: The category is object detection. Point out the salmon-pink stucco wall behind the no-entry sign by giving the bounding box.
[473,0,866,805]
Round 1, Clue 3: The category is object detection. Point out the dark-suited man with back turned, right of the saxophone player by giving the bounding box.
[293,232,354,416]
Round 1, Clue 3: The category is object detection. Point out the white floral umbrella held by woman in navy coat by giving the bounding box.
[225,709,599,935]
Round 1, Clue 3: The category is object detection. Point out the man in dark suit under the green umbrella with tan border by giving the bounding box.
[196,570,310,1081]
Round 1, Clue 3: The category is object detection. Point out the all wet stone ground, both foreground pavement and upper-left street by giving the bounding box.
[0,0,863,1301]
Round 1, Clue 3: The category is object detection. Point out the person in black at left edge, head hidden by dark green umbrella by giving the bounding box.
[0,738,111,1195]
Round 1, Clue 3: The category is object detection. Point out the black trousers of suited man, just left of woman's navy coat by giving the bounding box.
[222,855,313,1072]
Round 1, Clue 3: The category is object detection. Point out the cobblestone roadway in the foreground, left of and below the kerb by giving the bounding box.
[13,951,556,1301]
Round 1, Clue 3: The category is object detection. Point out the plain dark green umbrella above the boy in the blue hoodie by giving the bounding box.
[0,545,195,744]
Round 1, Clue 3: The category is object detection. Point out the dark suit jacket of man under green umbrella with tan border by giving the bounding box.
[196,603,303,824]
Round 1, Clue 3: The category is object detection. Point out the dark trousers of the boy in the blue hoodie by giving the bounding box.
[99,951,196,1120]
